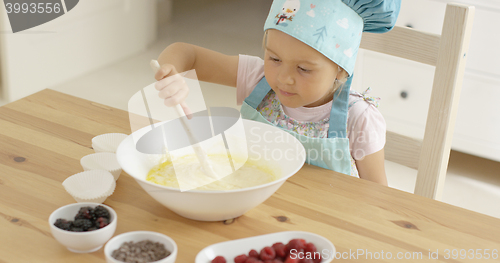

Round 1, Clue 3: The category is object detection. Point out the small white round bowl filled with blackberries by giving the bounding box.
[49,203,118,253]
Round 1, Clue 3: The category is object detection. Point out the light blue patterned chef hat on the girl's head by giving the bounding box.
[264,0,401,76]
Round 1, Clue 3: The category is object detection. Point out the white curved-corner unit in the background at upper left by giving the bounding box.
[0,0,157,102]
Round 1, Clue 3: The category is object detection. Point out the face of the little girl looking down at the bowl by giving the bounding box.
[264,29,339,108]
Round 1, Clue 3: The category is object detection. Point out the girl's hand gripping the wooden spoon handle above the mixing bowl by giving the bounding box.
[155,64,191,118]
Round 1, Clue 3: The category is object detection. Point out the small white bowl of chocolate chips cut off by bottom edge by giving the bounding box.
[104,231,177,263]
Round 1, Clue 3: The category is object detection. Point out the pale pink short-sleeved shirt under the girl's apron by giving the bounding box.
[236,55,386,160]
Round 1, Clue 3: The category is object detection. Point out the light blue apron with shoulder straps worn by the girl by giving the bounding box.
[241,77,352,175]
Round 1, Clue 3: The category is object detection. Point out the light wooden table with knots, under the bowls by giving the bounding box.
[0,90,500,263]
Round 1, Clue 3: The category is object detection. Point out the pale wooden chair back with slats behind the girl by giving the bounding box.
[361,3,475,200]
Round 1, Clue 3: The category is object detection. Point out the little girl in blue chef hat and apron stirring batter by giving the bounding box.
[155,0,401,185]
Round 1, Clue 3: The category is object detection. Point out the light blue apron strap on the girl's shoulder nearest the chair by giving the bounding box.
[328,75,352,138]
